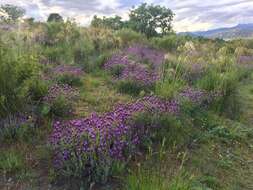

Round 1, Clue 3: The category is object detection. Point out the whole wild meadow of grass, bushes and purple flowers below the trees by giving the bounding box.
[0,2,253,190]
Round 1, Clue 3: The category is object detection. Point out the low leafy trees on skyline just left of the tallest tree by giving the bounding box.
[91,15,124,30]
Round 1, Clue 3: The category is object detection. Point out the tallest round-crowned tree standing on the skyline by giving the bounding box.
[129,3,174,37]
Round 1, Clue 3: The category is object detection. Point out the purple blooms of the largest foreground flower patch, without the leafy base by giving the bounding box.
[50,96,179,167]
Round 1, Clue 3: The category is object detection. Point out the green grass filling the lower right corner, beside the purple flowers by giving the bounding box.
[125,73,253,190]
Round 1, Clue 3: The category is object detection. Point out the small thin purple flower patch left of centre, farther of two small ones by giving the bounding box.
[52,65,83,76]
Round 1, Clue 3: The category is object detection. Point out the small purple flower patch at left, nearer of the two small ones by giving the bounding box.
[43,84,79,103]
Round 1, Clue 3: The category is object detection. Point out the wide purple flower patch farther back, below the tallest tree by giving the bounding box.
[104,45,164,85]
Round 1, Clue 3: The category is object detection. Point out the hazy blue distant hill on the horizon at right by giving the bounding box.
[179,23,253,40]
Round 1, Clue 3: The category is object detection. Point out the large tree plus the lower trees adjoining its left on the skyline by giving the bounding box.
[91,3,174,37]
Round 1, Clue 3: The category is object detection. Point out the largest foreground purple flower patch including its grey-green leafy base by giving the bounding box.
[51,97,178,184]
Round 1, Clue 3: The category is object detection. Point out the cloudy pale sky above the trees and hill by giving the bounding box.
[0,0,253,32]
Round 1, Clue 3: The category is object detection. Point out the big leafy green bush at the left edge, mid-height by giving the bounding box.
[0,43,38,118]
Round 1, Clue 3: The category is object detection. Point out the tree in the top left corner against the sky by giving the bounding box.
[1,4,25,21]
